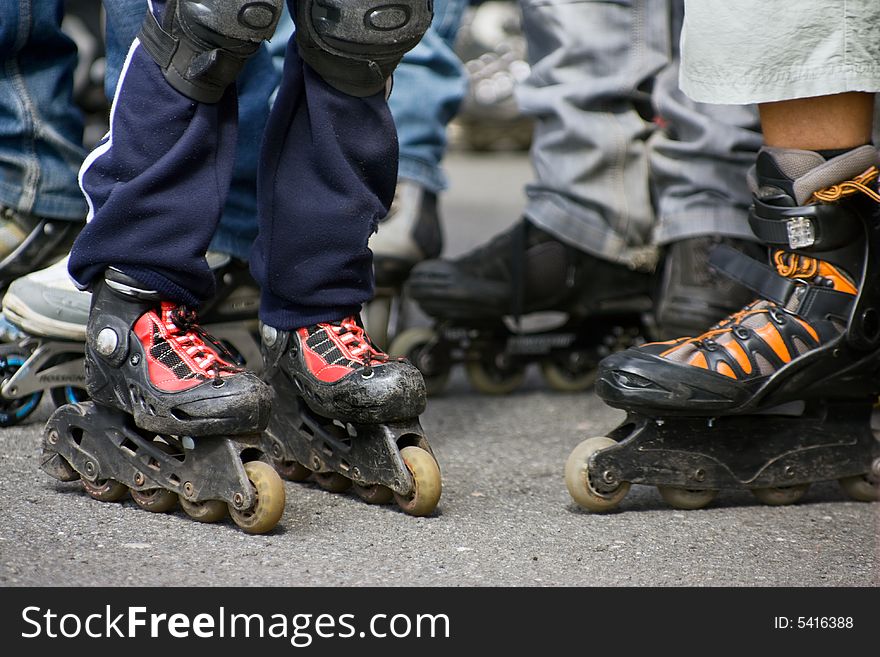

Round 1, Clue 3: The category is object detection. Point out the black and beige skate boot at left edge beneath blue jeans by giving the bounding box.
[0,207,83,290]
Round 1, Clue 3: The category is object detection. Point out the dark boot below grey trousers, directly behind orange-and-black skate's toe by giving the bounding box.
[655,235,767,340]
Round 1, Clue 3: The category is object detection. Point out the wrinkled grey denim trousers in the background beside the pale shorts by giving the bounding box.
[517,0,760,270]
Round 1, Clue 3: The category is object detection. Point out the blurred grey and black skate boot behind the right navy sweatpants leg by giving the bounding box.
[364,178,443,348]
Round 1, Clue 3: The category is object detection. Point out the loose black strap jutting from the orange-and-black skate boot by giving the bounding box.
[709,244,855,321]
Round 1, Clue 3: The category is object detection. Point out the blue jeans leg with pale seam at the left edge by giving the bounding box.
[0,0,86,221]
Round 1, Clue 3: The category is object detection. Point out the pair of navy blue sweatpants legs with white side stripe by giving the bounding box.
[70,0,398,330]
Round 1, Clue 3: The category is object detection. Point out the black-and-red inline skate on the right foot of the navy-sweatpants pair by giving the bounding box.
[262,317,441,516]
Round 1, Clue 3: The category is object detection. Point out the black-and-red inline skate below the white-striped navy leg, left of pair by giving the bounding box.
[42,269,284,533]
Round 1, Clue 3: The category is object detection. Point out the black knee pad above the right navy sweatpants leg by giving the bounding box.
[294,0,434,97]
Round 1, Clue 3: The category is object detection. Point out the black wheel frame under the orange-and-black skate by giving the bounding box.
[589,402,880,492]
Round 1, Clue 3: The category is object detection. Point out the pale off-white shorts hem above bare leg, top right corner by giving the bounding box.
[680,0,880,105]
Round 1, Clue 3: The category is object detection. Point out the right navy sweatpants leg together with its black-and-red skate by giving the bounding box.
[251,5,439,515]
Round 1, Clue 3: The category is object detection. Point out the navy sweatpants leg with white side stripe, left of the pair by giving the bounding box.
[70,3,237,305]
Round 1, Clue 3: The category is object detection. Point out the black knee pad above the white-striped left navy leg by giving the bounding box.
[138,0,284,103]
